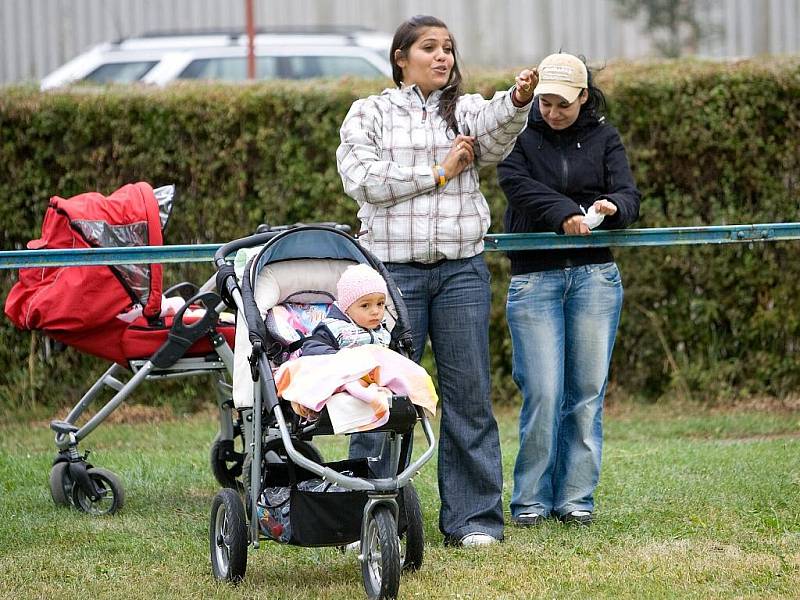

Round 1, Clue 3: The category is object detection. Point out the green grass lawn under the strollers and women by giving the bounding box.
[0,406,800,599]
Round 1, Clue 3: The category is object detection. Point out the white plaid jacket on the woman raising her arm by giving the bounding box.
[336,86,533,263]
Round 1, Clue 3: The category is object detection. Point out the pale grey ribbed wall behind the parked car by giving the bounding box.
[0,0,800,83]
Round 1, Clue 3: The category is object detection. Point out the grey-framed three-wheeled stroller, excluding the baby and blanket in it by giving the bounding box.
[209,225,435,598]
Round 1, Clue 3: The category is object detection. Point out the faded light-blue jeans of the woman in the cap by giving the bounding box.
[506,262,623,517]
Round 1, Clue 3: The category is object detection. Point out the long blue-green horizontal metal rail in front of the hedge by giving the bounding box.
[0,223,800,269]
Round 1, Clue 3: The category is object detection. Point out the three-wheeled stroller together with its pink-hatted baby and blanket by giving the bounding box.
[209,226,435,598]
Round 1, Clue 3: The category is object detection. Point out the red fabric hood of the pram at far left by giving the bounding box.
[5,182,166,362]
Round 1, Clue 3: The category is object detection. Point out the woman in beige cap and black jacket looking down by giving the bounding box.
[498,54,640,526]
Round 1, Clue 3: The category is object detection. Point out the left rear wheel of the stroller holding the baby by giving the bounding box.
[209,488,247,583]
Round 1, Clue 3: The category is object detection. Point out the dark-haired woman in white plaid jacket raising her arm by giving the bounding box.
[336,16,537,546]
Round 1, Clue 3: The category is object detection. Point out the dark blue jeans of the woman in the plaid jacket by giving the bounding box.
[350,255,503,543]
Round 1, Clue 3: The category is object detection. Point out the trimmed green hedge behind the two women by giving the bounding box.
[0,59,800,406]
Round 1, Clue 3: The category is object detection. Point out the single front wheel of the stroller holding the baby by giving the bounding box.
[361,505,400,600]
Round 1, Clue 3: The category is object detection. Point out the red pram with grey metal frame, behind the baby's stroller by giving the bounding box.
[5,182,243,514]
